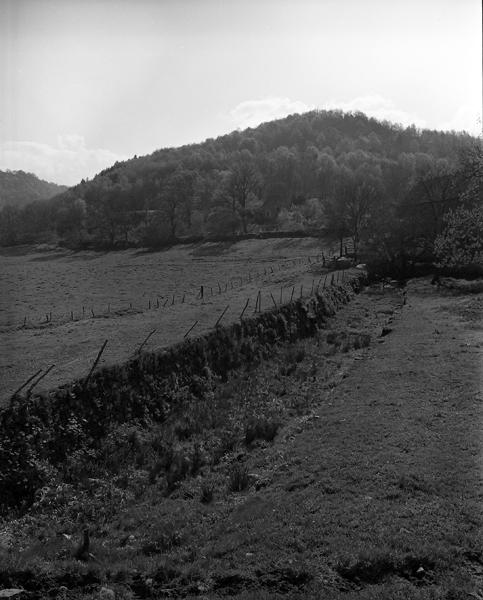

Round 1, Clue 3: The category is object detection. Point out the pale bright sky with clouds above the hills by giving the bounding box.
[0,0,482,185]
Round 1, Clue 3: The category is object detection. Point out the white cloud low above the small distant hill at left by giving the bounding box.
[0,134,126,185]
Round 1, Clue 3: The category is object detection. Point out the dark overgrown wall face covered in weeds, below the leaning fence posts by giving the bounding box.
[0,275,363,508]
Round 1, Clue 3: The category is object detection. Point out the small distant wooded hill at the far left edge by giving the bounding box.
[0,171,67,208]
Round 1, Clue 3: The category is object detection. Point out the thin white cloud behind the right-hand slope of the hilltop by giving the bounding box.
[323,94,427,128]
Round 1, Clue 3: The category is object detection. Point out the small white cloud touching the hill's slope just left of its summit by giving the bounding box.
[229,97,313,129]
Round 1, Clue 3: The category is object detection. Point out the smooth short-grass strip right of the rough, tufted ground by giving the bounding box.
[190,282,483,599]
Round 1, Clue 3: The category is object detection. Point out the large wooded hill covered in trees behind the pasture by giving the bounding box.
[0,111,481,268]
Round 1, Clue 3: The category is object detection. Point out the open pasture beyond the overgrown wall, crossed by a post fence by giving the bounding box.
[0,238,346,401]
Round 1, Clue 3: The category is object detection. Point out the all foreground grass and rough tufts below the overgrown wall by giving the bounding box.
[0,288,482,600]
